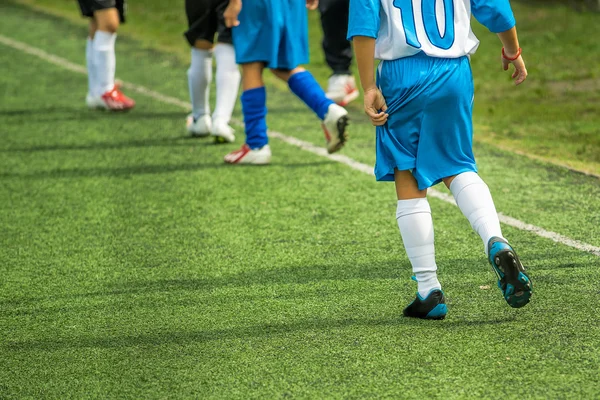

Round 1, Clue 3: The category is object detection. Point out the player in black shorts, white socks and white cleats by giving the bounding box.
[185,0,240,142]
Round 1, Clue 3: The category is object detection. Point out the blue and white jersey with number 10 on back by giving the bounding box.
[348,0,515,60]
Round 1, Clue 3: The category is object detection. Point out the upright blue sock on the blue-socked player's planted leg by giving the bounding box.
[241,86,269,149]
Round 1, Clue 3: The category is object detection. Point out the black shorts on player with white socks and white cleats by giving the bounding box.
[184,0,233,46]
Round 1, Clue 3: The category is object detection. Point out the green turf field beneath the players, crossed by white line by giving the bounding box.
[0,1,600,399]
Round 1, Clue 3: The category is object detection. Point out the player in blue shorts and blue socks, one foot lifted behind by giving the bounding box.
[224,0,348,164]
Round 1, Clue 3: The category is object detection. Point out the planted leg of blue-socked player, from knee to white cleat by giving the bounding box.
[225,62,271,165]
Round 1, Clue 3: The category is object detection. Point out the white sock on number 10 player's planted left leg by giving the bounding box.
[396,198,442,298]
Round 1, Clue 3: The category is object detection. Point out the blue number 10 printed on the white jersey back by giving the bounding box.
[394,0,454,50]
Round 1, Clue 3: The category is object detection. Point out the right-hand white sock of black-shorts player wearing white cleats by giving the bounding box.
[213,43,242,123]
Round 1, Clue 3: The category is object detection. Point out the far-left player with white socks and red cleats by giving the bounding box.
[78,0,135,111]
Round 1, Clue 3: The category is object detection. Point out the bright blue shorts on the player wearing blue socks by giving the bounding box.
[232,0,308,70]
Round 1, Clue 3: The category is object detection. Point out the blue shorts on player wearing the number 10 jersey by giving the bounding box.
[375,53,477,190]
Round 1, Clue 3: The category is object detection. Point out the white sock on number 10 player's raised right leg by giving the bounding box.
[450,172,502,254]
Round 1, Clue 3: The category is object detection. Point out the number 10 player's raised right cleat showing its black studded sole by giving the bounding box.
[488,237,533,308]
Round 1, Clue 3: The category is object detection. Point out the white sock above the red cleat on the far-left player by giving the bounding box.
[94,31,117,94]
